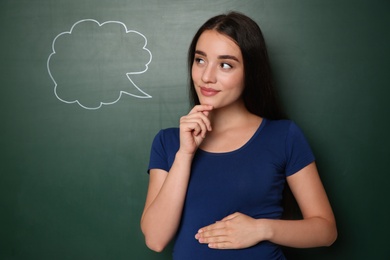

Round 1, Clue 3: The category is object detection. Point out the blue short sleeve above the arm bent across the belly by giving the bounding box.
[285,122,315,176]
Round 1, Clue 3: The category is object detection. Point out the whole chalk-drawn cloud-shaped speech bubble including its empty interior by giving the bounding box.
[47,19,152,110]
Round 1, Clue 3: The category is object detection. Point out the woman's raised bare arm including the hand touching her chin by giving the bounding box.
[141,105,212,252]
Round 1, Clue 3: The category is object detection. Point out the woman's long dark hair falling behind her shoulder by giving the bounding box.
[188,12,285,119]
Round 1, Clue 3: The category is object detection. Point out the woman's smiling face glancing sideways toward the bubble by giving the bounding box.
[192,30,244,109]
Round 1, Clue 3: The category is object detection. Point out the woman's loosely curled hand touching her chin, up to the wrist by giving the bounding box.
[180,105,213,154]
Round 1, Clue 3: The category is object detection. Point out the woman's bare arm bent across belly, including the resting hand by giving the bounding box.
[196,163,337,249]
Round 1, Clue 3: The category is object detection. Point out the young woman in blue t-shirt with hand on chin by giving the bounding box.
[141,12,337,260]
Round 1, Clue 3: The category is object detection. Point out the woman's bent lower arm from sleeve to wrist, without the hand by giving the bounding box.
[268,163,337,248]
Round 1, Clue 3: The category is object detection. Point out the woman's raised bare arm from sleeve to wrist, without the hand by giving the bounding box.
[141,153,192,252]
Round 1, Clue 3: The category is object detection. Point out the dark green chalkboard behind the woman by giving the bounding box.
[0,0,390,259]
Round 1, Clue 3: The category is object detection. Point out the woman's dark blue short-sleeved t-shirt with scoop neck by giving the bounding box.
[149,119,314,260]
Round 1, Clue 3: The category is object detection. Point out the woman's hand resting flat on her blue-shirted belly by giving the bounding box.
[195,212,264,249]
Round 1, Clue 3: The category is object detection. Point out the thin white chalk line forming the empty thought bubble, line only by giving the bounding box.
[47,19,152,110]
